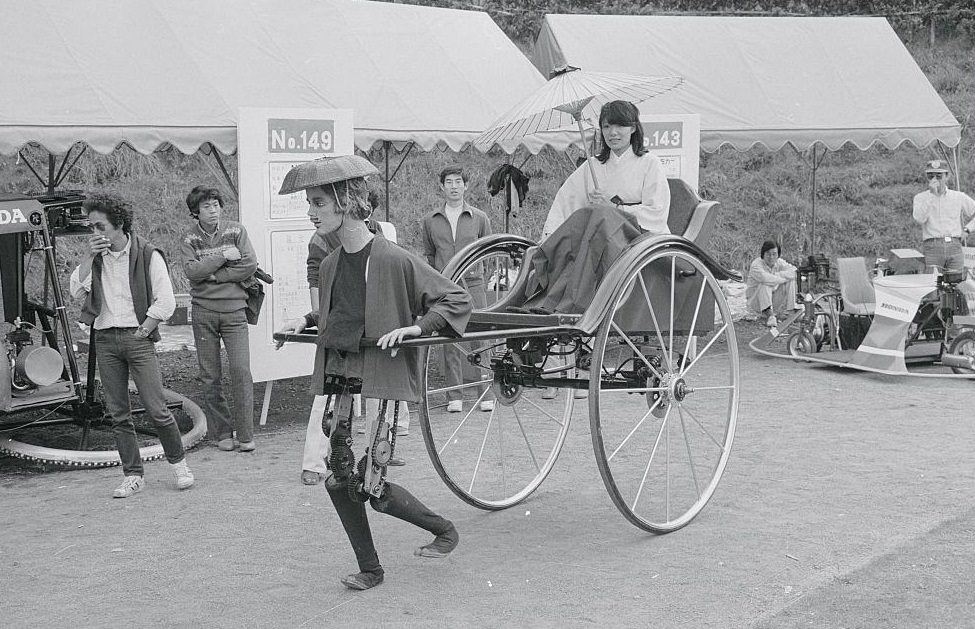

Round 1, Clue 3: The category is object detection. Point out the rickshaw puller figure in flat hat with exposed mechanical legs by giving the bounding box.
[279,155,472,590]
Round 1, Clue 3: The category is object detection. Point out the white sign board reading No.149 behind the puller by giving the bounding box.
[237,108,355,382]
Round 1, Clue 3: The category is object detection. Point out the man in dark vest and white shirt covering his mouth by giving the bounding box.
[70,196,194,498]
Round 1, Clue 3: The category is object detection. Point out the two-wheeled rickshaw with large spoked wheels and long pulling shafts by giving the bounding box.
[275,184,740,533]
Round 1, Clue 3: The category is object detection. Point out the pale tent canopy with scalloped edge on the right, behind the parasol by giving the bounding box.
[533,15,961,151]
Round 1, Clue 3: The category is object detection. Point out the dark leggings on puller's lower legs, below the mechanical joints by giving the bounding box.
[325,476,453,572]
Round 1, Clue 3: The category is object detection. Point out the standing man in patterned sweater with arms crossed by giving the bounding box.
[182,186,257,452]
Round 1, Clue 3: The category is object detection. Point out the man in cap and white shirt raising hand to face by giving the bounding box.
[914,160,975,271]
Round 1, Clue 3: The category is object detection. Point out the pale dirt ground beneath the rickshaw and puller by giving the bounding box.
[0,323,975,628]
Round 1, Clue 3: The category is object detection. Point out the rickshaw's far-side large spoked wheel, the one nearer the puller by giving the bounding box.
[420,236,574,510]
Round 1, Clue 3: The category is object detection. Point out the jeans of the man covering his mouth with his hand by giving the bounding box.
[95,328,183,476]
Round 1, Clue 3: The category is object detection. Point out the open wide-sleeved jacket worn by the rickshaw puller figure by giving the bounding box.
[309,234,473,402]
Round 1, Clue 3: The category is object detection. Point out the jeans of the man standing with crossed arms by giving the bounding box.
[193,305,254,442]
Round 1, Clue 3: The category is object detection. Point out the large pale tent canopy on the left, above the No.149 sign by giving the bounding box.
[0,0,545,153]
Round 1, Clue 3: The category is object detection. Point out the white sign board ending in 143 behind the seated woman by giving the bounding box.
[640,114,701,192]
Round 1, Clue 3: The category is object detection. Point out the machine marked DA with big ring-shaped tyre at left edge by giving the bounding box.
[0,192,206,467]
